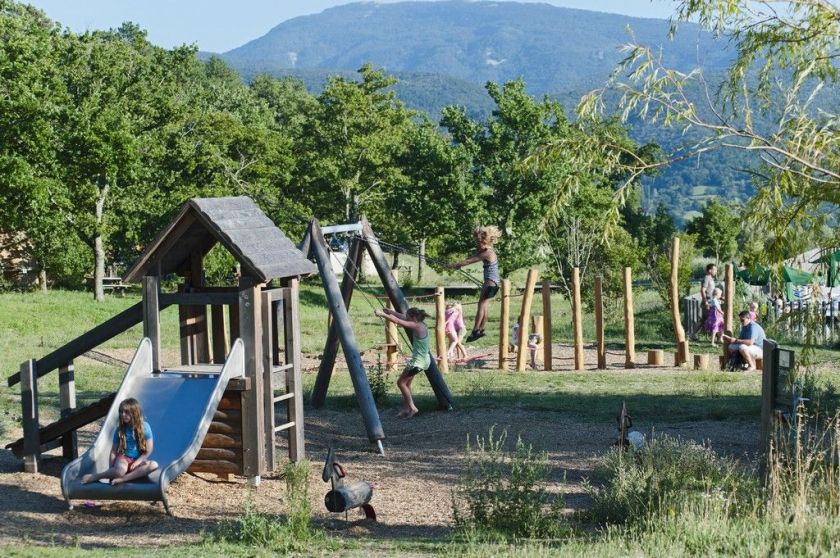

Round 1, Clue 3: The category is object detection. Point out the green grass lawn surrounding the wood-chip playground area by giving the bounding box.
[0,284,840,556]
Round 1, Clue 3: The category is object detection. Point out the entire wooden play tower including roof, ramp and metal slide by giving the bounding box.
[7,197,316,503]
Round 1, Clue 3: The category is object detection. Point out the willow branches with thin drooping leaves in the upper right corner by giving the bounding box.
[579,0,840,262]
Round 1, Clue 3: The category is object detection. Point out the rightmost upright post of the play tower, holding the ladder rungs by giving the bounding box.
[283,278,306,463]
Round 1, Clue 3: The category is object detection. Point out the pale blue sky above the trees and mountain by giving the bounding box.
[20,0,676,52]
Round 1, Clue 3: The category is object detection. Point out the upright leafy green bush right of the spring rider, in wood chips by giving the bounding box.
[452,428,569,539]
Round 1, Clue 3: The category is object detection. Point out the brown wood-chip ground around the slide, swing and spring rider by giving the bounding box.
[0,347,755,547]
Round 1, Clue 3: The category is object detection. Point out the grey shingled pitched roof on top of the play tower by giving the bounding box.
[123,196,317,283]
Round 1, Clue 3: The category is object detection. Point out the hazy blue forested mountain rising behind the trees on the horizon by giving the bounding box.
[212,0,750,221]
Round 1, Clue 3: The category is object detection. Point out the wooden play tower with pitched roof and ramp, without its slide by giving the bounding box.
[9,197,317,479]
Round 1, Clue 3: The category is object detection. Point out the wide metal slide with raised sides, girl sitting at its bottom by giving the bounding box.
[61,338,245,515]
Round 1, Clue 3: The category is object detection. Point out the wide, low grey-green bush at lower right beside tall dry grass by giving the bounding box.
[586,436,755,524]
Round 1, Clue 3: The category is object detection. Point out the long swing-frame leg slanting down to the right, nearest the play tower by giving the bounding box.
[309,219,390,443]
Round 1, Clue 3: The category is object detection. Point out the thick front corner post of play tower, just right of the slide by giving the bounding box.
[239,276,264,483]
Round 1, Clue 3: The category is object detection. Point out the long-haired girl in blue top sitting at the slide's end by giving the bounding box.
[82,397,158,485]
